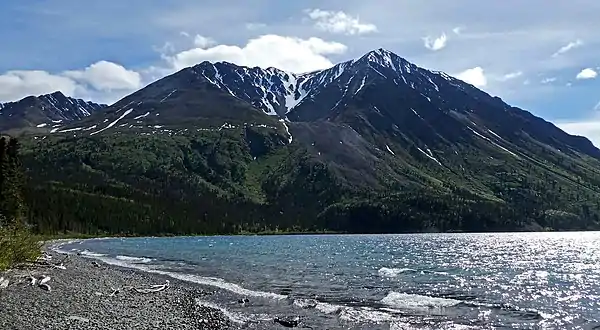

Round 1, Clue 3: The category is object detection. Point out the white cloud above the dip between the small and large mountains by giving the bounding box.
[63,61,142,91]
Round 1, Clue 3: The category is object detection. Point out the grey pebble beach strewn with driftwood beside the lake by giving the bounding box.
[0,251,237,330]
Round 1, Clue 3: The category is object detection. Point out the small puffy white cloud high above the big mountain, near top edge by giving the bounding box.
[306,9,377,35]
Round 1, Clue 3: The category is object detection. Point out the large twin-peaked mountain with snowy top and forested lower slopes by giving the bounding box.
[15,49,600,234]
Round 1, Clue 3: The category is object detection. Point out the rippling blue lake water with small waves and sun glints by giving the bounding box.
[60,232,600,329]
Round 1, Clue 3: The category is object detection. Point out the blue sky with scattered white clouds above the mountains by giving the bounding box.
[0,0,600,145]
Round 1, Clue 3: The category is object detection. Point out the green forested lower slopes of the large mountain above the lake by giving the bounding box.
[12,124,599,235]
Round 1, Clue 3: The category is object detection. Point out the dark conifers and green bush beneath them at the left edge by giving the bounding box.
[0,137,40,270]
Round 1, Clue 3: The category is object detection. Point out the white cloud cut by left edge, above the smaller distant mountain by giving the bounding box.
[0,71,78,102]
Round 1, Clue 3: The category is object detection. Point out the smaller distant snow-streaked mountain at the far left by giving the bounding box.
[0,92,106,132]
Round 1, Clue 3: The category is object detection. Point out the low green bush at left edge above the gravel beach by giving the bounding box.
[0,222,42,270]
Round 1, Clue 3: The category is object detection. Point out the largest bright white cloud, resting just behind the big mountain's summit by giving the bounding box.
[166,35,347,72]
